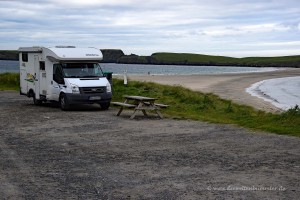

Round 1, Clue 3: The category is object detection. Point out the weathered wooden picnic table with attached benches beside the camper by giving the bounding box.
[112,96,168,119]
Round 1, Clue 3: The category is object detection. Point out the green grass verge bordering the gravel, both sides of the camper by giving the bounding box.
[0,73,300,137]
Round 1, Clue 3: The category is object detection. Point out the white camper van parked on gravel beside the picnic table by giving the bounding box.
[19,46,112,110]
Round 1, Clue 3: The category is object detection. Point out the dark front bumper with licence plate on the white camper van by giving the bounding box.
[65,92,112,104]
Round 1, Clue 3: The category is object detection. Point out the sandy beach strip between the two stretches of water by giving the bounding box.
[128,68,300,112]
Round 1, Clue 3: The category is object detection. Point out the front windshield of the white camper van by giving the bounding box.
[61,63,103,78]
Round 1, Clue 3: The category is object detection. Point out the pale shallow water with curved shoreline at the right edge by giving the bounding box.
[246,76,300,110]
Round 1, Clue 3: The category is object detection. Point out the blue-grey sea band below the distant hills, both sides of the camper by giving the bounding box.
[0,60,276,75]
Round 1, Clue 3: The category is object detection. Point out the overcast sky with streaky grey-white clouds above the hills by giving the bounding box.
[0,0,300,57]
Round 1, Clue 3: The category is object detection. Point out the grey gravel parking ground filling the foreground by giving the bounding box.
[0,92,300,199]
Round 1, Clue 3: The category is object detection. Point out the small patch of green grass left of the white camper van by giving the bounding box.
[0,73,20,90]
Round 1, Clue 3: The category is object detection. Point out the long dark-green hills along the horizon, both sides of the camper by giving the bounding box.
[0,49,300,68]
